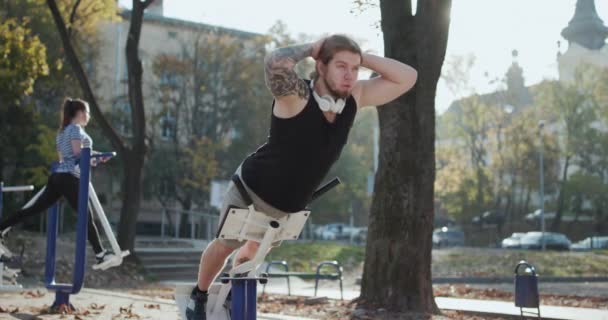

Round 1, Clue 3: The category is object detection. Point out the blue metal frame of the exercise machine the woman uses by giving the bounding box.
[44,148,91,309]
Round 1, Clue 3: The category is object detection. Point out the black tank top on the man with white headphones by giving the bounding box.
[241,82,357,212]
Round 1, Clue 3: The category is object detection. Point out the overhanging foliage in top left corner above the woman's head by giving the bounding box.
[0,0,118,127]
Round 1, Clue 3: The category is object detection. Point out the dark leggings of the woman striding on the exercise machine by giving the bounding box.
[0,172,103,254]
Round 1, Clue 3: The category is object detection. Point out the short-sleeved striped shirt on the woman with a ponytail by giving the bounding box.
[55,124,93,178]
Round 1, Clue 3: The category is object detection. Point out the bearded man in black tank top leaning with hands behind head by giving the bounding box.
[186,35,417,320]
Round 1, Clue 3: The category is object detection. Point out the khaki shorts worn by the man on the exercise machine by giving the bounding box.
[217,167,289,249]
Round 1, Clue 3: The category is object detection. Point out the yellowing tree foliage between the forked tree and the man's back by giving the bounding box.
[148,31,271,208]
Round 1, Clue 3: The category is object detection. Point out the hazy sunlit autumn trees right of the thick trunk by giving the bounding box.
[435,59,608,228]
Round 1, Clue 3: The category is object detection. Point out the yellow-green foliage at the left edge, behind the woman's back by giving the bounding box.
[0,18,55,195]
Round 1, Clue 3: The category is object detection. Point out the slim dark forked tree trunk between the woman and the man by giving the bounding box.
[47,0,153,252]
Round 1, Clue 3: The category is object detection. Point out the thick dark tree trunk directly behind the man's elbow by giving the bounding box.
[359,0,451,313]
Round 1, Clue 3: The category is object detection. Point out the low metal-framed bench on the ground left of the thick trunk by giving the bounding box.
[262,260,344,300]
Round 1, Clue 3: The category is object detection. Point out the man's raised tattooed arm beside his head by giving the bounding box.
[264,45,312,99]
